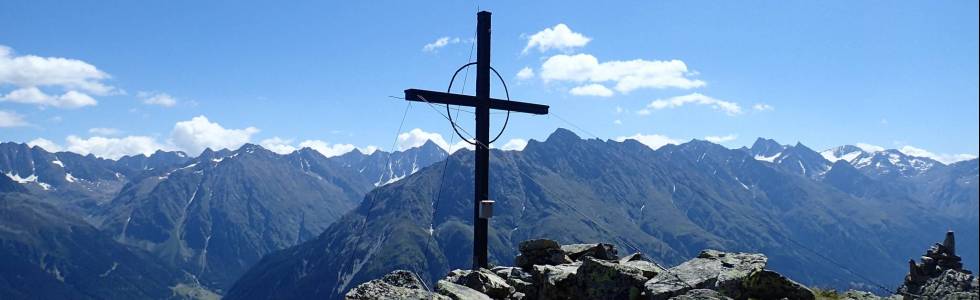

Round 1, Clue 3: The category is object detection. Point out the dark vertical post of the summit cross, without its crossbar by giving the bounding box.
[473,11,490,269]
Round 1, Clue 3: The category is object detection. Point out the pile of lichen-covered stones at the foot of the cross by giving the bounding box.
[346,239,815,300]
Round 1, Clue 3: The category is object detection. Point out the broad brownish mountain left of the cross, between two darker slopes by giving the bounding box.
[101,144,371,290]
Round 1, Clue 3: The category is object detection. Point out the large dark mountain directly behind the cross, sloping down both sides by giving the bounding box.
[227,129,972,299]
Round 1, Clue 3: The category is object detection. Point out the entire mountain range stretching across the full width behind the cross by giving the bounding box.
[0,129,980,299]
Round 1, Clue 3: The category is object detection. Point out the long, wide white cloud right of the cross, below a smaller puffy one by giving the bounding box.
[540,54,705,93]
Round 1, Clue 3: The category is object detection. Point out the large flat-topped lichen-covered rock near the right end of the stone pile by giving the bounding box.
[644,250,767,299]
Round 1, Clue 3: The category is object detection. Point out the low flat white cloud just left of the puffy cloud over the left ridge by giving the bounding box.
[64,135,167,159]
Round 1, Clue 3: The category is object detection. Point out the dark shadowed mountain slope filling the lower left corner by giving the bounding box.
[0,193,209,299]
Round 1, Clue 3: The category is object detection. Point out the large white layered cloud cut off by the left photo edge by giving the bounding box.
[0,45,121,108]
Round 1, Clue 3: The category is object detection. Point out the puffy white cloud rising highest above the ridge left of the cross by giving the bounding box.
[170,116,259,155]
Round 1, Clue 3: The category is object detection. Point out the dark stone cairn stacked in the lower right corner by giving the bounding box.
[898,231,980,299]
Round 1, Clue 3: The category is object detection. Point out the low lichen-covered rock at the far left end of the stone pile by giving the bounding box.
[344,270,449,300]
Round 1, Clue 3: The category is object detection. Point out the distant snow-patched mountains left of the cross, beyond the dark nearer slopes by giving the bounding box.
[0,142,448,298]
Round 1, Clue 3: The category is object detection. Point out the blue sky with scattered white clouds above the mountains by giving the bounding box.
[0,0,980,164]
